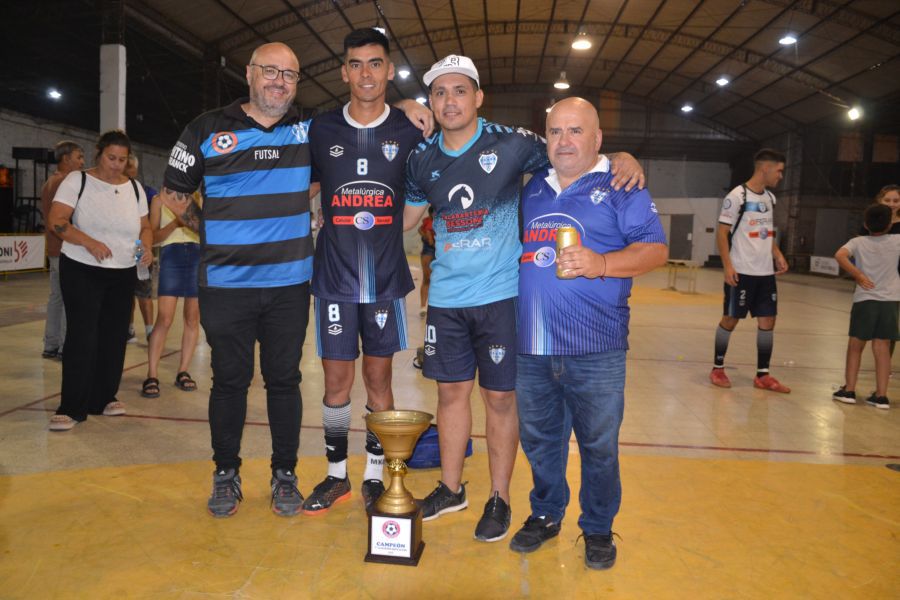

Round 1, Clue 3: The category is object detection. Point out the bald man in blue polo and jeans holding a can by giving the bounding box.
[510,98,668,569]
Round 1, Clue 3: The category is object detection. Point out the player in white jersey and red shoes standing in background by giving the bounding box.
[709,148,791,394]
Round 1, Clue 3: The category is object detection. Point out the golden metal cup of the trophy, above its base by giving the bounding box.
[366,410,433,515]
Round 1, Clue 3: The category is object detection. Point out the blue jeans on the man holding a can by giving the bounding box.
[516,350,625,535]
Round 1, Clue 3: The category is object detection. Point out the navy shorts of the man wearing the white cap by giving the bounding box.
[422,298,516,392]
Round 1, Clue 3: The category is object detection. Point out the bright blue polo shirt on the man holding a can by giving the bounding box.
[518,157,666,355]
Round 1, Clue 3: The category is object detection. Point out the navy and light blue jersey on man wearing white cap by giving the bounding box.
[406,119,548,308]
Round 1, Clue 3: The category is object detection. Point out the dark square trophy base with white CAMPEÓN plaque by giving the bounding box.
[365,508,425,567]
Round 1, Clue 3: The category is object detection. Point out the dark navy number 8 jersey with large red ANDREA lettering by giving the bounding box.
[309,106,422,304]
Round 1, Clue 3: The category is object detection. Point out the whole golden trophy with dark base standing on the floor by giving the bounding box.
[366,410,432,566]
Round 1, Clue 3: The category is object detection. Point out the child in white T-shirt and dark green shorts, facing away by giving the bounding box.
[832,204,900,409]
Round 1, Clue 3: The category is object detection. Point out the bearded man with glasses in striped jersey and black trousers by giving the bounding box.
[160,43,313,517]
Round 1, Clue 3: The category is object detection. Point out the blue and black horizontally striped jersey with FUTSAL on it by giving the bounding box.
[165,98,313,288]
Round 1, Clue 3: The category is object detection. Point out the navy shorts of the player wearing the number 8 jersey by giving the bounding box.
[316,298,408,360]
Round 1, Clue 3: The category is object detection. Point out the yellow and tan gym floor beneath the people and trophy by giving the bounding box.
[0,259,900,600]
